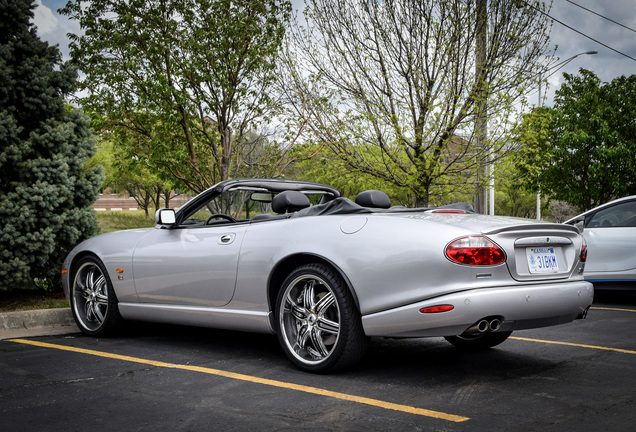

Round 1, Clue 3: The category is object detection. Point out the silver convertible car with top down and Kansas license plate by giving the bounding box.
[62,179,593,372]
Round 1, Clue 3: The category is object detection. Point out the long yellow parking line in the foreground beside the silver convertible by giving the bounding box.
[7,339,470,422]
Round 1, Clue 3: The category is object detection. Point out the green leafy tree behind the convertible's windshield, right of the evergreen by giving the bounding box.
[62,0,291,192]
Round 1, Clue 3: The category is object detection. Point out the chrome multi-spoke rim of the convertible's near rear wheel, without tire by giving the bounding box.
[278,274,340,365]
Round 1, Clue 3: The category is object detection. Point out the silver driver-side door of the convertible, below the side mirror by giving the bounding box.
[133,224,248,307]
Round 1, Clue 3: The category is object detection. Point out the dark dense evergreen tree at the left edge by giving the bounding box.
[0,0,102,290]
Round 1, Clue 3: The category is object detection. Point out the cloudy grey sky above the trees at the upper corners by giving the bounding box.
[34,0,636,105]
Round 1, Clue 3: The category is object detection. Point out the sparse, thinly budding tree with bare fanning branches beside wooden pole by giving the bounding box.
[285,0,549,205]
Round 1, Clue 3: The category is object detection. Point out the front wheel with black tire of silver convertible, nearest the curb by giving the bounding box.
[70,256,123,336]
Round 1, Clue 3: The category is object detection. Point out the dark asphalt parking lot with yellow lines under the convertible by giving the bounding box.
[0,294,636,431]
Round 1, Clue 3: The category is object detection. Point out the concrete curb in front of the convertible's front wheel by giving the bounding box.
[0,308,79,339]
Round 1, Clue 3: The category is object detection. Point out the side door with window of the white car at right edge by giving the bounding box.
[583,201,636,280]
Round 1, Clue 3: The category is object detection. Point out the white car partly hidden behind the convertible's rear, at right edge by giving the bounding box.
[565,195,636,290]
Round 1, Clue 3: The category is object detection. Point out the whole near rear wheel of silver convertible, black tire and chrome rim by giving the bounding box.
[276,264,368,373]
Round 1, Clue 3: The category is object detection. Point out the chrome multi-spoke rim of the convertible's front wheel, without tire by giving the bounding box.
[72,261,109,332]
